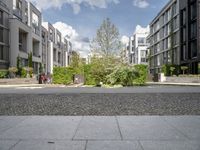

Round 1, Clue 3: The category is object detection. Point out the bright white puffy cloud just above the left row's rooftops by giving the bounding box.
[53,22,90,57]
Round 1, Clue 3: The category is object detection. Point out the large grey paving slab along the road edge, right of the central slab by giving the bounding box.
[117,116,186,140]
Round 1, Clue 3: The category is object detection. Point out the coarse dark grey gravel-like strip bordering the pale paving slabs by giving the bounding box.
[0,93,200,116]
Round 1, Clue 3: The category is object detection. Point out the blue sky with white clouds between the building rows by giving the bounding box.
[29,0,169,57]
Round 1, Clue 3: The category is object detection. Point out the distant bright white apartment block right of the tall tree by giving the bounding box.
[129,26,149,64]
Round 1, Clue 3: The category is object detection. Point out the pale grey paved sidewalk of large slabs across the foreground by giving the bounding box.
[0,116,200,150]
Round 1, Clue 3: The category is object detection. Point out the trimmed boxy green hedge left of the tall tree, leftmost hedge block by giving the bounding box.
[53,67,75,84]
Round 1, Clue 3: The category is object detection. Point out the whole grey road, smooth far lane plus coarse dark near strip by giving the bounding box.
[0,86,200,116]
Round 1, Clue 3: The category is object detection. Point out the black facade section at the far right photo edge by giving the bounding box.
[179,0,200,74]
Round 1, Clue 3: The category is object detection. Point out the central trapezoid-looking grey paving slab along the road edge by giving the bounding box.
[74,116,121,140]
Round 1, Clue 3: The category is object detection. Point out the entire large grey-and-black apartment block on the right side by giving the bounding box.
[148,0,200,74]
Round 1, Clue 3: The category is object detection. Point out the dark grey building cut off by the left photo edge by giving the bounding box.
[0,0,12,69]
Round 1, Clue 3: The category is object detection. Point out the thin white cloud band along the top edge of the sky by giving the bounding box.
[29,0,119,14]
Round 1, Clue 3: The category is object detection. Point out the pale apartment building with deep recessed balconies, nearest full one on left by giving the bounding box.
[9,0,42,74]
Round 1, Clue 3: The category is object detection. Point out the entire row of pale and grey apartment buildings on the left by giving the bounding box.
[0,0,72,74]
